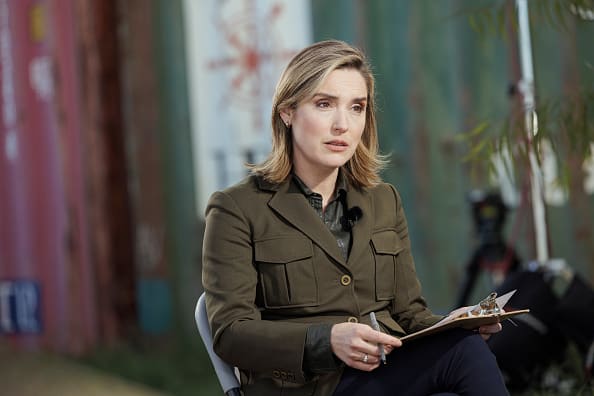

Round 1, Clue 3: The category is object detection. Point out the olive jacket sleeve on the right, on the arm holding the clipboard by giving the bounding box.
[390,186,442,333]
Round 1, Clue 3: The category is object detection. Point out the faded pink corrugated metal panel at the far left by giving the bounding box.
[0,0,95,352]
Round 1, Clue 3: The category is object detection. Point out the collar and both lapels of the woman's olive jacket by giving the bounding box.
[257,172,374,266]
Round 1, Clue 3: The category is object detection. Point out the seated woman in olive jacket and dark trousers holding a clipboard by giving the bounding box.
[203,40,507,396]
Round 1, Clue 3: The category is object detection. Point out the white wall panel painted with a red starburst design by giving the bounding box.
[184,0,311,216]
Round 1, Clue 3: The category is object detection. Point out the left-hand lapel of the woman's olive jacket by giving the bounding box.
[260,179,345,265]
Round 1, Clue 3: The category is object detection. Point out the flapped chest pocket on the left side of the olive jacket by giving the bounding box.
[254,237,319,308]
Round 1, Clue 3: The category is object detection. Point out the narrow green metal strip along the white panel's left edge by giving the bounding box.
[153,0,203,339]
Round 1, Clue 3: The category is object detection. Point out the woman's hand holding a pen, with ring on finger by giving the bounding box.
[330,322,402,371]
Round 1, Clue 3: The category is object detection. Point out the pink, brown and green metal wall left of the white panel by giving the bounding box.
[0,0,201,354]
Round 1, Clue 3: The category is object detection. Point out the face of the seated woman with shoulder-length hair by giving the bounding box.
[281,68,367,175]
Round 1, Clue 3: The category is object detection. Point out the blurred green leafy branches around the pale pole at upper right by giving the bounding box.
[457,0,594,190]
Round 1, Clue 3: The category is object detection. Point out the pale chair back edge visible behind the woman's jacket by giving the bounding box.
[195,293,241,396]
